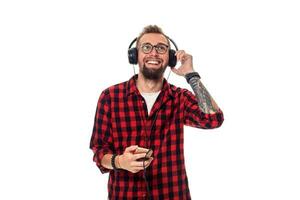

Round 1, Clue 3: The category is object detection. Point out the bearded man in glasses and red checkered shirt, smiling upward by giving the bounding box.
[90,25,223,200]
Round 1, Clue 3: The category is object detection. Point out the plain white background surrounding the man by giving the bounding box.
[0,0,300,200]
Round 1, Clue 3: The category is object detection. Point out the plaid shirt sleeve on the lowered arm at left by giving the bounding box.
[90,90,113,173]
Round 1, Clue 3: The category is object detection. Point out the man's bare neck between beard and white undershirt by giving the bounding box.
[136,73,164,93]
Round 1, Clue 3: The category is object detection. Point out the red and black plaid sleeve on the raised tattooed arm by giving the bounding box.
[184,90,224,129]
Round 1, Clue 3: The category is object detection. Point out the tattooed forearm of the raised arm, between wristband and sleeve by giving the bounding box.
[189,77,217,113]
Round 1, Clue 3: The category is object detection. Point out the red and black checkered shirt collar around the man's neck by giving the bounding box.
[126,74,175,98]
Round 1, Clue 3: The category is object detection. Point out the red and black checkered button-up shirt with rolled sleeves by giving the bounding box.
[90,76,223,200]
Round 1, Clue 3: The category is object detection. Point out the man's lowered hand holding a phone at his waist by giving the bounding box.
[119,145,153,173]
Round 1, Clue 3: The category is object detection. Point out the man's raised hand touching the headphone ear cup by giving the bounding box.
[171,50,194,76]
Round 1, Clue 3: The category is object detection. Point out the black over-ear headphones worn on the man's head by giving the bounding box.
[128,36,178,67]
